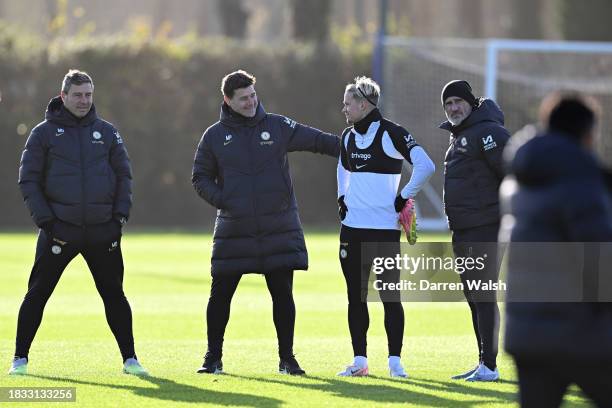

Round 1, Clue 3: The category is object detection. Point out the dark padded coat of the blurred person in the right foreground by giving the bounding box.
[500,128,612,364]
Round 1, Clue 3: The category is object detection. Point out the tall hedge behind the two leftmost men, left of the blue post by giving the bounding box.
[0,26,371,227]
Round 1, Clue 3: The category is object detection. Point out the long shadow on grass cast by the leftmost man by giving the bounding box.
[28,375,283,407]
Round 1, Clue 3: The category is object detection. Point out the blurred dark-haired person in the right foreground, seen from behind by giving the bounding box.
[500,95,612,407]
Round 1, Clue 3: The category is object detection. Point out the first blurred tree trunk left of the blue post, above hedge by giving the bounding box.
[291,0,332,42]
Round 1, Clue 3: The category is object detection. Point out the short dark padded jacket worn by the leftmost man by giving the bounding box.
[19,96,132,227]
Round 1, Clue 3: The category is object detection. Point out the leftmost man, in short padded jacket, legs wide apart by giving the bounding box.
[11,70,145,374]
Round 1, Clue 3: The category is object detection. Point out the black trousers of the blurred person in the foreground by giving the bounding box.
[515,358,612,408]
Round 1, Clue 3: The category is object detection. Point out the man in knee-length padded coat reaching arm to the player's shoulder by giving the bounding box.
[192,71,340,374]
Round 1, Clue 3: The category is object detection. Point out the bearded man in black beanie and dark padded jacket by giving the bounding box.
[440,80,510,381]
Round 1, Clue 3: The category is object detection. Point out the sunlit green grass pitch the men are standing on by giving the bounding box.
[0,232,584,407]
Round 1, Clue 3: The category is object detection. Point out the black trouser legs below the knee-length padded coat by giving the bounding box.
[206,270,295,358]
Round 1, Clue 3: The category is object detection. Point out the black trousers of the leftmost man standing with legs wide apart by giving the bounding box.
[15,221,134,360]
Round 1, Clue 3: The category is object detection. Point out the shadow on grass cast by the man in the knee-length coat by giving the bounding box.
[226,374,506,407]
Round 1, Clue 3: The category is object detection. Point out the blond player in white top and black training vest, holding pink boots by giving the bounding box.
[337,77,435,378]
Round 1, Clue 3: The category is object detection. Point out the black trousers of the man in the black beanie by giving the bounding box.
[453,224,499,369]
